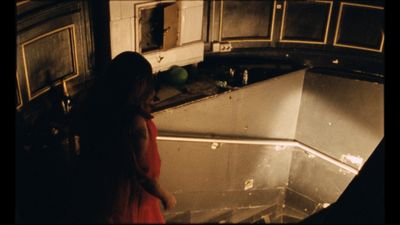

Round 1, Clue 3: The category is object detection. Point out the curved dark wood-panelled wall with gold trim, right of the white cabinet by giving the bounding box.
[203,0,385,76]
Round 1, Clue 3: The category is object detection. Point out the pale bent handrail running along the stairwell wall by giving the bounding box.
[157,136,359,175]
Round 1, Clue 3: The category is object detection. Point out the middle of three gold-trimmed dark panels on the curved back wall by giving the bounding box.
[280,1,332,44]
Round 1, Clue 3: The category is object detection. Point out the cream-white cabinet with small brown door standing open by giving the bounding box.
[110,0,204,73]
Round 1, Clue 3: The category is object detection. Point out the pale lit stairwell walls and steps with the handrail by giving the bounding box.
[155,70,383,223]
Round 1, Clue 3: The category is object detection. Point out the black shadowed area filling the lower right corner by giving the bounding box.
[301,139,385,224]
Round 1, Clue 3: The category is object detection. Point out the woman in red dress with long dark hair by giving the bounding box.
[76,52,176,223]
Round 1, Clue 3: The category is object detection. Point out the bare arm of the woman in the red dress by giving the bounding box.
[132,116,176,209]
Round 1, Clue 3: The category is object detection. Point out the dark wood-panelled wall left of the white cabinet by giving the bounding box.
[16,1,109,118]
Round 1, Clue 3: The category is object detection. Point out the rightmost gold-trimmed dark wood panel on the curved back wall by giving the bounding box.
[335,2,384,51]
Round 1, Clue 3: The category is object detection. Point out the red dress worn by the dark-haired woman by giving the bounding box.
[132,119,165,223]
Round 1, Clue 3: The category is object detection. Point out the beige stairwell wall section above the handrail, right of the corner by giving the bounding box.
[296,73,384,168]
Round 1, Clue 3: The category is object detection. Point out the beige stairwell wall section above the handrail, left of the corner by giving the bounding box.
[154,70,305,139]
